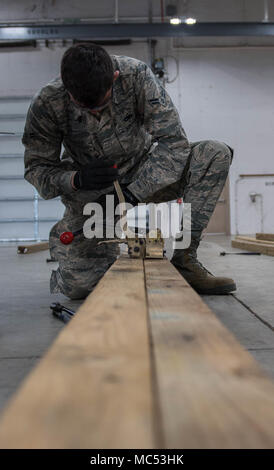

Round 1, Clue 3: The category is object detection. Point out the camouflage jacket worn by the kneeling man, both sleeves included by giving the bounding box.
[22,56,190,211]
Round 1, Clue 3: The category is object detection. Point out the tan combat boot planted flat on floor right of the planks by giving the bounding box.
[171,238,236,295]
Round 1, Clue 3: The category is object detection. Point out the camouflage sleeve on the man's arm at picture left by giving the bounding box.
[22,95,74,199]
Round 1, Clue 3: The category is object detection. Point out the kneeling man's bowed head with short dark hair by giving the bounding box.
[61,42,114,108]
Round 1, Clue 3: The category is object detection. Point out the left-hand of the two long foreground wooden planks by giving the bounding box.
[0,258,156,449]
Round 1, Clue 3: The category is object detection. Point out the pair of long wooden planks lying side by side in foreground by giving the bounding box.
[0,257,274,449]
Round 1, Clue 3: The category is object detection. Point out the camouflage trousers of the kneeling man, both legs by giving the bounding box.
[49,140,233,299]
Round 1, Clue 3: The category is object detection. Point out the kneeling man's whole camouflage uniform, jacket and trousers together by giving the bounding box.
[22,56,231,298]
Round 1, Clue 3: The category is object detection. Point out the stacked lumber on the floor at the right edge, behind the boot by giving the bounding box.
[231,233,274,256]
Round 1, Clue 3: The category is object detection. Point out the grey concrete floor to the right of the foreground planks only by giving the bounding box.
[198,236,274,379]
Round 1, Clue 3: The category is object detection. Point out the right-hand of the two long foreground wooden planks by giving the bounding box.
[145,260,274,449]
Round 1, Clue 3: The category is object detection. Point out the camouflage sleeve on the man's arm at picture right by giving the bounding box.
[128,63,190,202]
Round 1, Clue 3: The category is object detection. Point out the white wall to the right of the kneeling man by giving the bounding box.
[164,48,274,233]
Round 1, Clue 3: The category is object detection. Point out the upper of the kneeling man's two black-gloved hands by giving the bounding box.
[72,159,118,190]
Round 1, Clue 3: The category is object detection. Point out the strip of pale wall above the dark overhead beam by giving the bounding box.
[0,0,274,22]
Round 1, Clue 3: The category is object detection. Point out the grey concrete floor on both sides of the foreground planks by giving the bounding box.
[0,236,274,410]
